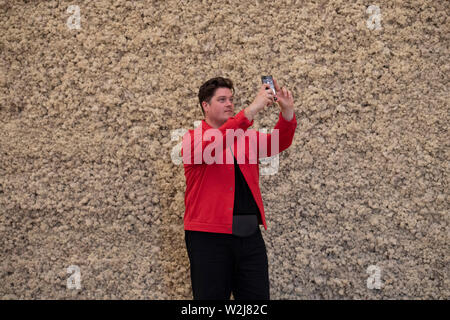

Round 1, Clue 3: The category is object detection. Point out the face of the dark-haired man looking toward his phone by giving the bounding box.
[203,88,234,127]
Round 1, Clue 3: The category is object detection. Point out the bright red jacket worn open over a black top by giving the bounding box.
[181,110,297,234]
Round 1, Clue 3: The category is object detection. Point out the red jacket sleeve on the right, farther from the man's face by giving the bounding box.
[257,112,297,158]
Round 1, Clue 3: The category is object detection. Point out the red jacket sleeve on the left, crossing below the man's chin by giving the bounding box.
[181,109,254,164]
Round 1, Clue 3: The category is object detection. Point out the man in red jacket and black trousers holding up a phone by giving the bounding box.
[181,77,297,300]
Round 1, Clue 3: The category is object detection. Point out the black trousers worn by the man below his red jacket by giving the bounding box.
[185,228,270,300]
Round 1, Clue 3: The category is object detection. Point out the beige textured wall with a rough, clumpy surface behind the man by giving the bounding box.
[0,0,450,299]
